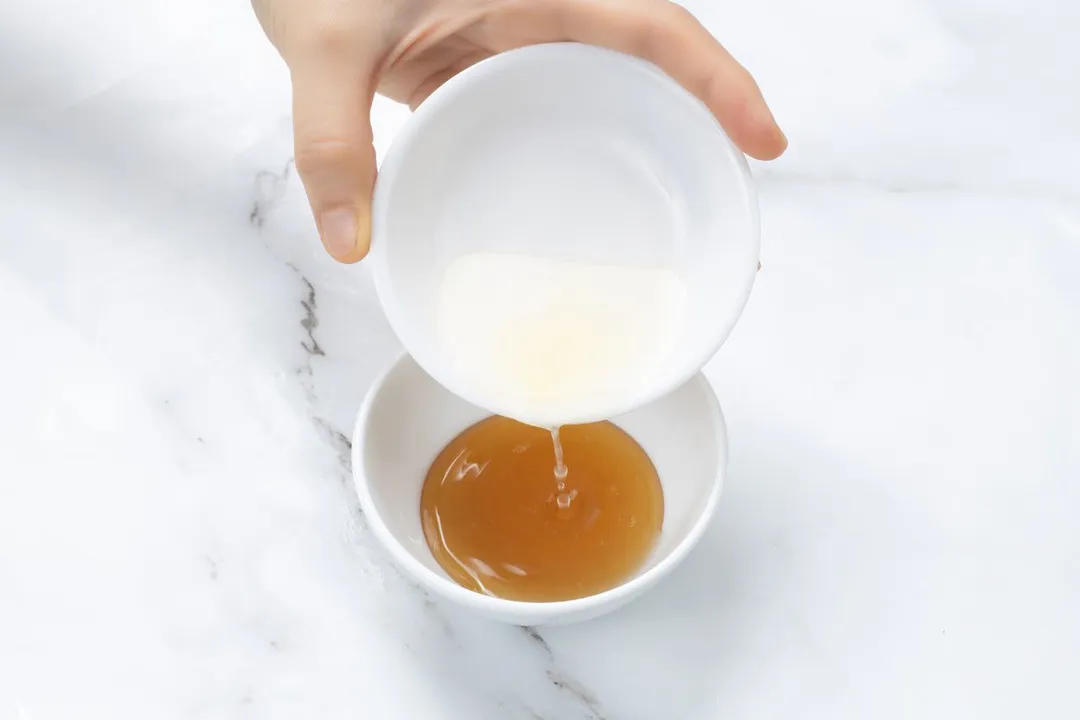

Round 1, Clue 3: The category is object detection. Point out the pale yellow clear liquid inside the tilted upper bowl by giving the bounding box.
[437,253,686,427]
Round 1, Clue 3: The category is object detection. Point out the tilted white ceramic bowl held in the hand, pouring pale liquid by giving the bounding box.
[368,43,759,422]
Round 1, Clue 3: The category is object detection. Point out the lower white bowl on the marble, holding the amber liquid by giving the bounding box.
[352,355,727,625]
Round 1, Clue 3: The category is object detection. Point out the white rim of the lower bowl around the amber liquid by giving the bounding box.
[351,353,728,623]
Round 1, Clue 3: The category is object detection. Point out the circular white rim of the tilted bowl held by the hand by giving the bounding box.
[365,42,761,423]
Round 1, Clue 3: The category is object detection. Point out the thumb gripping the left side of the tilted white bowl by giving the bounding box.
[292,58,376,262]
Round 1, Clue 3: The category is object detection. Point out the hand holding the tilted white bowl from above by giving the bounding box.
[253,0,787,262]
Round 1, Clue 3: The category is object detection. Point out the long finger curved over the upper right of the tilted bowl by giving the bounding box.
[489,0,787,160]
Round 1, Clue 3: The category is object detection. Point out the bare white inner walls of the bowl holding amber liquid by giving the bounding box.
[354,356,726,585]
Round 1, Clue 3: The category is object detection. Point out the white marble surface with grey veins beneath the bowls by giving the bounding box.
[0,0,1080,720]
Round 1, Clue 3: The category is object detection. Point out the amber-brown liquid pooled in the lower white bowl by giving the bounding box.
[420,417,664,601]
